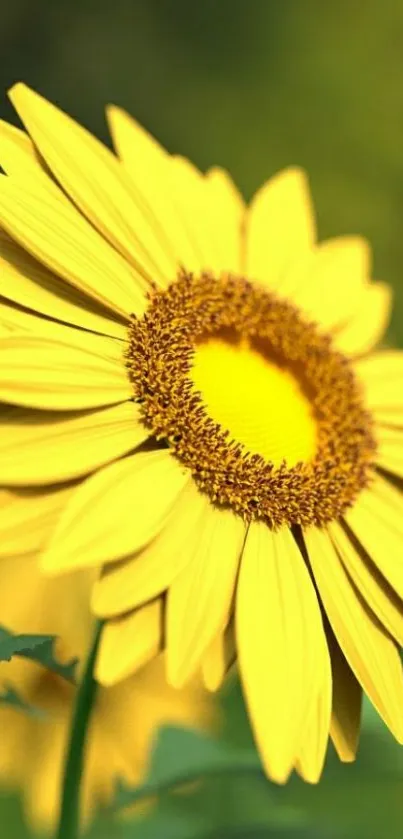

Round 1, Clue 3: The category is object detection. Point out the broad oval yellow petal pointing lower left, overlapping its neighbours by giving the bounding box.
[42,450,189,574]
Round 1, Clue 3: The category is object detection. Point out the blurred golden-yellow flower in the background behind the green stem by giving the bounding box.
[0,556,211,830]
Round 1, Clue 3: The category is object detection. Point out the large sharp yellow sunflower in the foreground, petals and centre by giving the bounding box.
[0,85,403,782]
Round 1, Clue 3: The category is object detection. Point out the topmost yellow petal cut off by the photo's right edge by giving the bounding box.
[354,350,403,412]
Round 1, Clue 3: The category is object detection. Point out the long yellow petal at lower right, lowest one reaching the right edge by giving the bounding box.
[304,528,403,742]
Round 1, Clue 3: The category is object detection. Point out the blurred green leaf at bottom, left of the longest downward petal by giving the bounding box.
[114,726,263,808]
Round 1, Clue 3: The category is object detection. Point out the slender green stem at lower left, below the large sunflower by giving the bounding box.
[56,621,102,839]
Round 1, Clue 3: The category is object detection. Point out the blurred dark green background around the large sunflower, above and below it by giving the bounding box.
[0,0,403,839]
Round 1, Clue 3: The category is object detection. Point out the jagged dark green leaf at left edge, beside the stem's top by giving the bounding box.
[0,626,77,683]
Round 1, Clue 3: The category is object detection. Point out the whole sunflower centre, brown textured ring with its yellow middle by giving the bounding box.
[127,274,375,528]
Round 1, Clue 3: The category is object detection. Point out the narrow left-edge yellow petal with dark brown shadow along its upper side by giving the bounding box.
[0,231,127,338]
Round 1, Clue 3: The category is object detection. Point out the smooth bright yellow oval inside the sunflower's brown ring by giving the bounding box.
[191,337,317,466]
